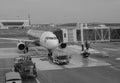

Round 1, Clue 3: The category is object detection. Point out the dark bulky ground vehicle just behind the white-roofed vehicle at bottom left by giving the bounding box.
[14,57,37,78]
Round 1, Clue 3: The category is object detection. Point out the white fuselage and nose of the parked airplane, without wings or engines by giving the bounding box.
[27,29,59,49]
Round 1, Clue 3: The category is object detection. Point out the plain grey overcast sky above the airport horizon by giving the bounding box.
[0,0,120,24]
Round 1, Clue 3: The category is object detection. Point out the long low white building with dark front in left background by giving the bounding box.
[0,20,29,29]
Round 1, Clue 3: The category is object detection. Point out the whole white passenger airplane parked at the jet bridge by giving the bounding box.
[0,29,67,57]
